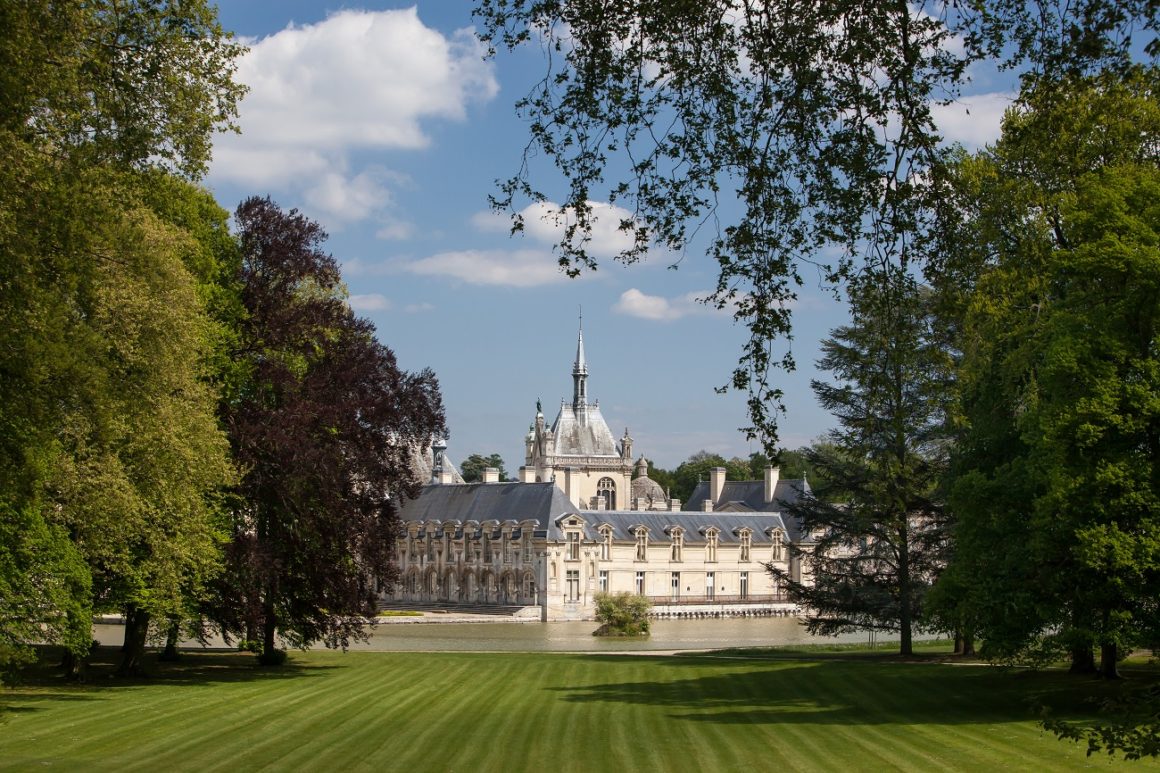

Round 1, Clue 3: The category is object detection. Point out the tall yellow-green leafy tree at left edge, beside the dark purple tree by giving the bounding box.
[0,0,242,670]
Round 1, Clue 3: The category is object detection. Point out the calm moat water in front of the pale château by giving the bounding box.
[93,617,904,652]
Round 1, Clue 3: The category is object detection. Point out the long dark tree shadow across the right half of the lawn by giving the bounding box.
[550,653,1141,725]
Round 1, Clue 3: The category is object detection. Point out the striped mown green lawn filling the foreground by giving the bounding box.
[0,650,1160,773]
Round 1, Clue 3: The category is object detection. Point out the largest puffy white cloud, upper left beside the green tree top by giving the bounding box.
[211,7,499,226]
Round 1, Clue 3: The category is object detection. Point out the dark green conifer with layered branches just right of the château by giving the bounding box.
[767,272,951,655]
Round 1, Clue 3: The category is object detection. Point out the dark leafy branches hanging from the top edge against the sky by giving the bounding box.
[476,0,1160,445]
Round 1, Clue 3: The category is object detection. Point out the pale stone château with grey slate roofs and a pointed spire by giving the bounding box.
[386,324,810,621]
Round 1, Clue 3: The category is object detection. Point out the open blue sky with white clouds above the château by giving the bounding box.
[205,0,1008,474]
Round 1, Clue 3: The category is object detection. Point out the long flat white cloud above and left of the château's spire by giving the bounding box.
[400,250,567,287]
